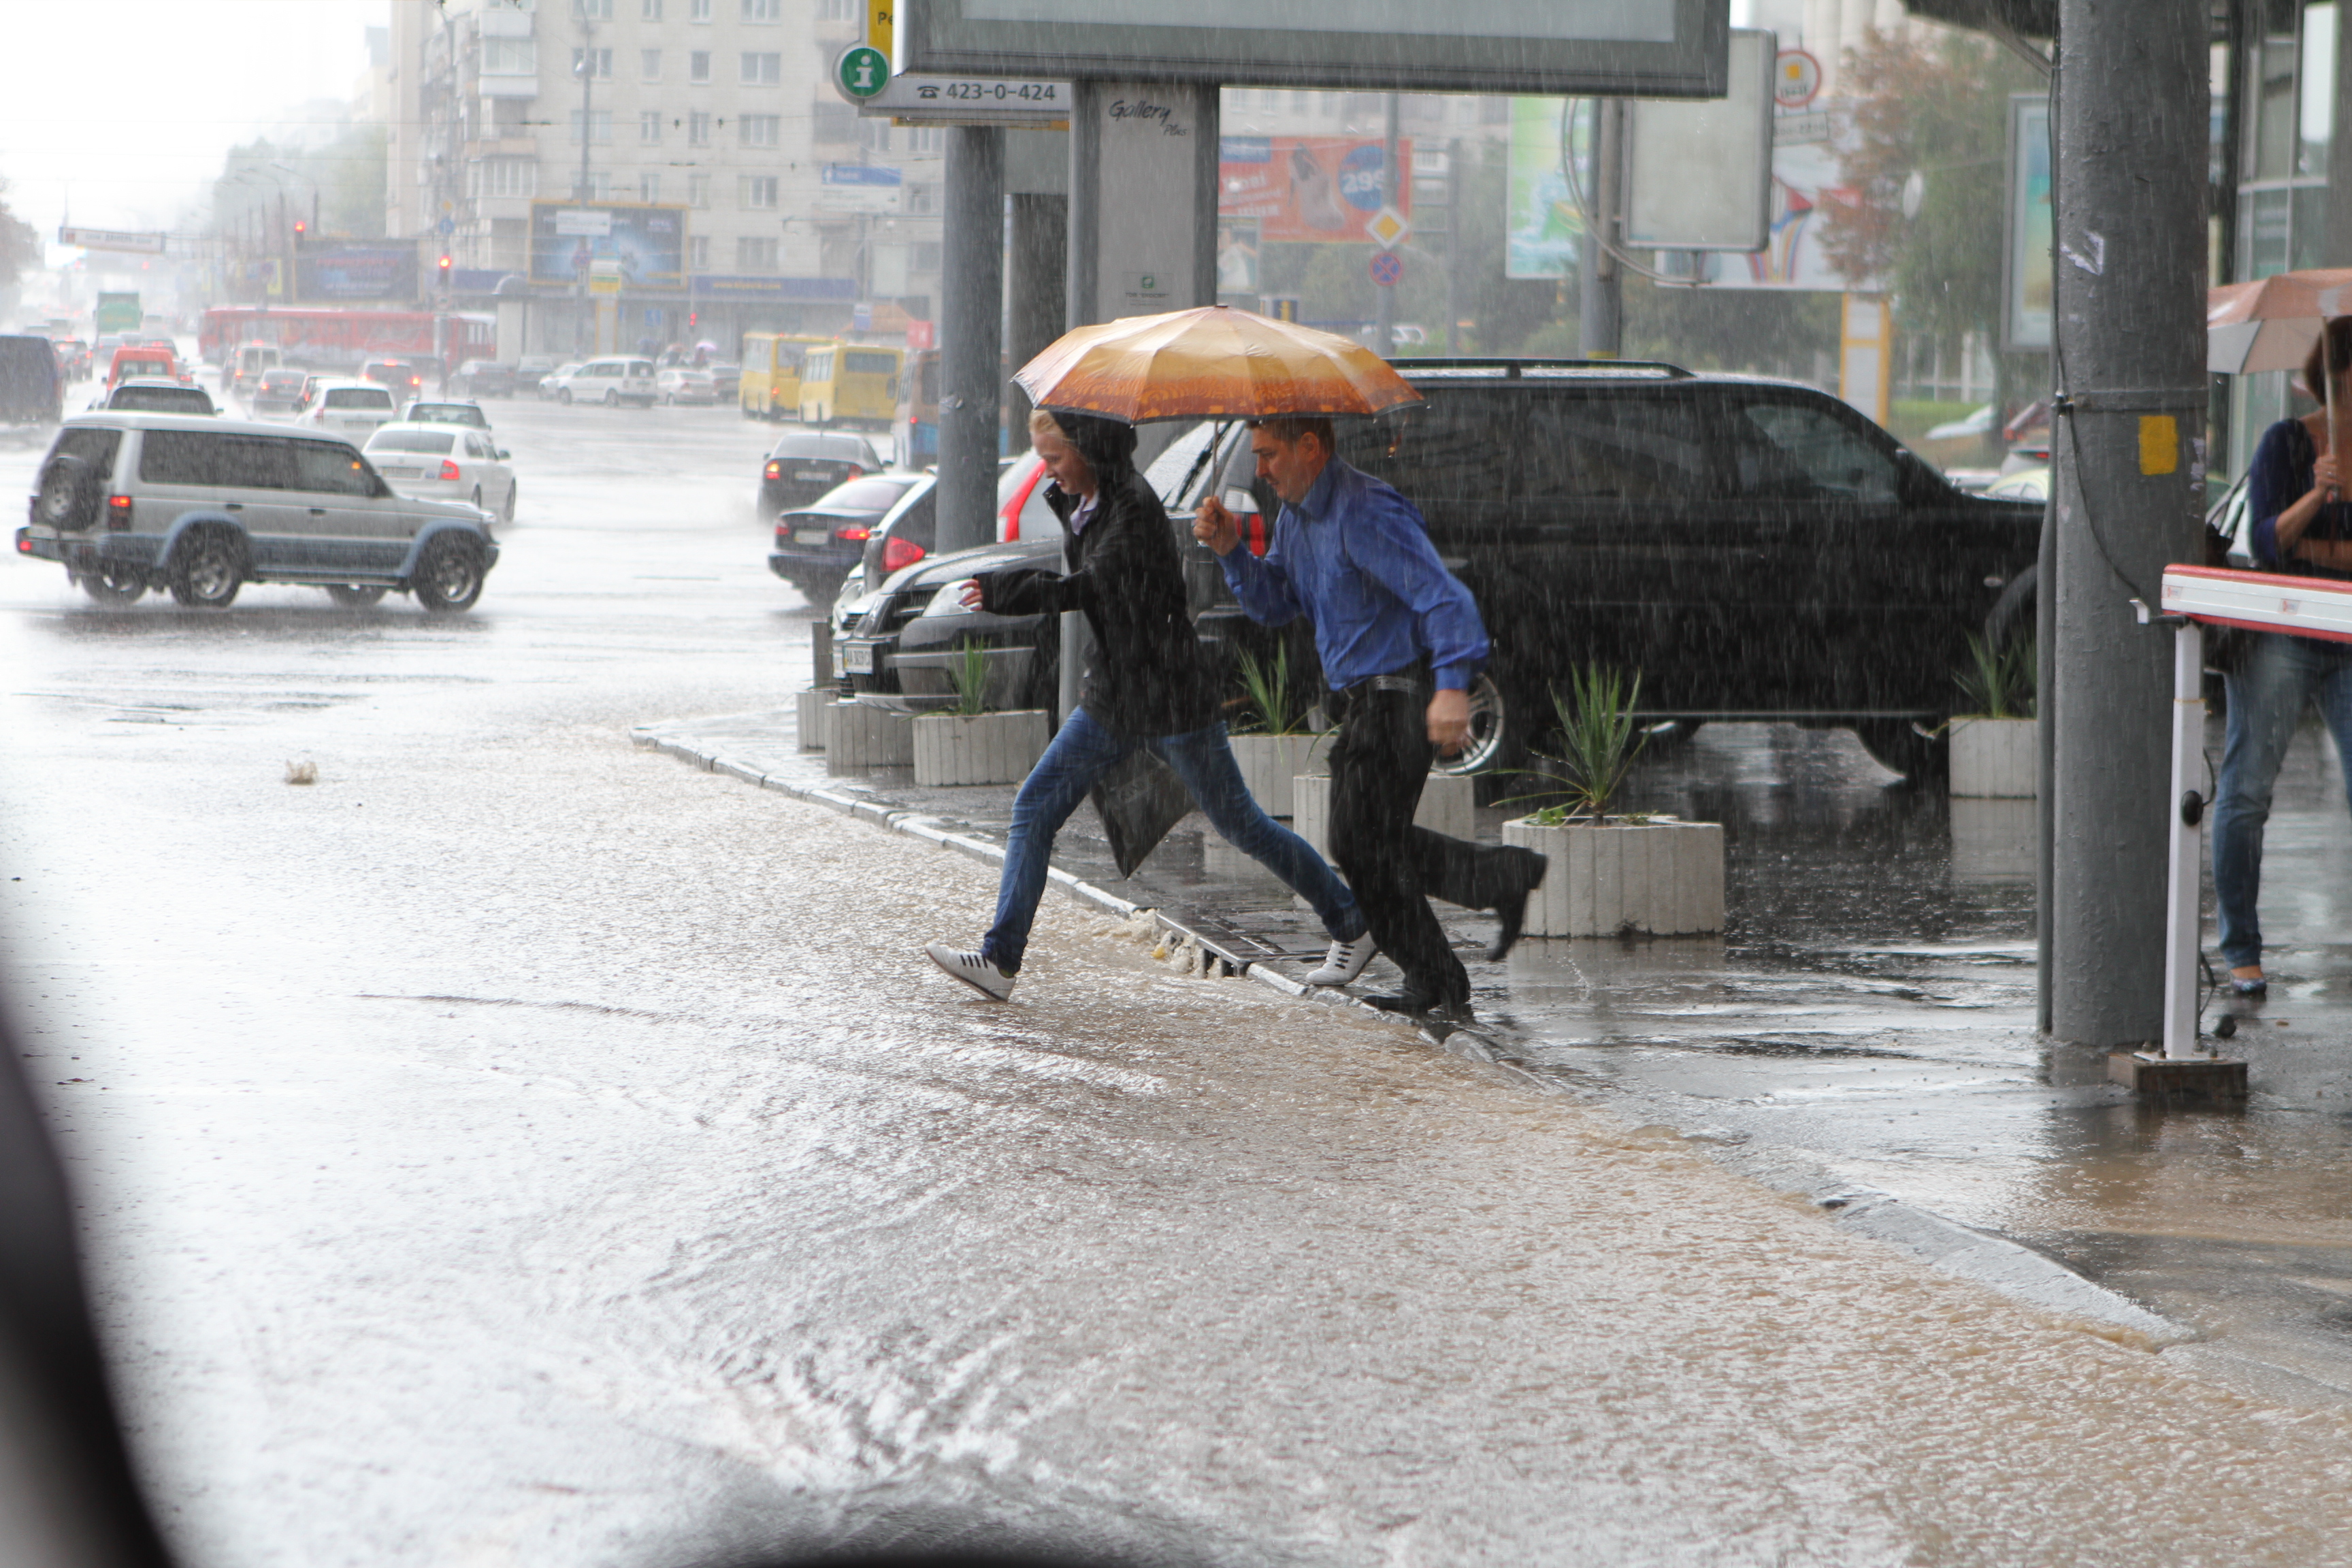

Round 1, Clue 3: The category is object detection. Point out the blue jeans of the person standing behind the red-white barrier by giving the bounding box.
[2213,632,2352,968]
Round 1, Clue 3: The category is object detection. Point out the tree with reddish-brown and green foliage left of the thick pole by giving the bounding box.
[1823,31,2042,392]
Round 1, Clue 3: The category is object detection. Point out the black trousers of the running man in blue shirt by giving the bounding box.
[1329,687,1510,1004]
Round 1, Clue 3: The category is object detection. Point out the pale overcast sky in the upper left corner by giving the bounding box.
[0,0,385,259]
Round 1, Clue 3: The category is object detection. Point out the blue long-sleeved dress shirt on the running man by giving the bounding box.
[1218,459,1486,691]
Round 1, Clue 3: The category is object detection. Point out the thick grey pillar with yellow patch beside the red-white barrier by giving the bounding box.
[2042,0,2208,1046]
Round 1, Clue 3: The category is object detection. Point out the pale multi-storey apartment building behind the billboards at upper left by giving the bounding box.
[386,0,943,353]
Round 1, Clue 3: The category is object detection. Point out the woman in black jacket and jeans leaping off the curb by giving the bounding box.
[924,409,1373,1002]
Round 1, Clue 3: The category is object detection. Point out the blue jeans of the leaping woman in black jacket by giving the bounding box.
[981,708,1364,971]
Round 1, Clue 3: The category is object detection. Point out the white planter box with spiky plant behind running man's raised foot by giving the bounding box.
[1503,816,1724,936]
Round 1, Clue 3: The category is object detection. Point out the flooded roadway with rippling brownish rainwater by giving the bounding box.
[14,407,2352,1566]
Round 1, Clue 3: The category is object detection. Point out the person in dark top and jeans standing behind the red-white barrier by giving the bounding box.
[2213,317,2352,997]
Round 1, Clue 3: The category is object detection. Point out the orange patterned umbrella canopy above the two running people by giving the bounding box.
[1014,306,1420,423]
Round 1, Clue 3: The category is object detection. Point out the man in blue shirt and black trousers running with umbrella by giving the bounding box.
[1192,419,1546,1018]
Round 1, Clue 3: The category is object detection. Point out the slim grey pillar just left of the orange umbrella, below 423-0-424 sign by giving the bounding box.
[938,125,1004,555]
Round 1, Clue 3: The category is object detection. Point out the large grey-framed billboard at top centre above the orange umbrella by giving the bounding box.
[894,0,1729,99]
